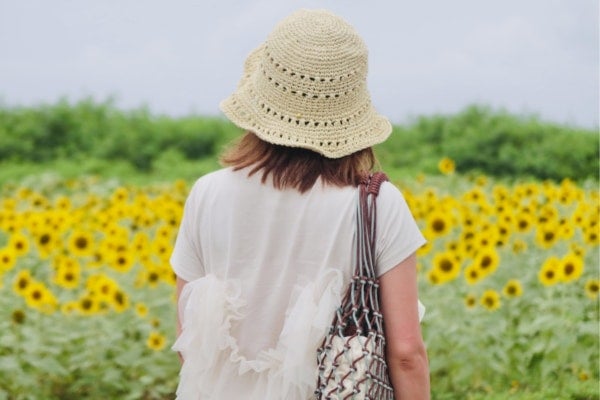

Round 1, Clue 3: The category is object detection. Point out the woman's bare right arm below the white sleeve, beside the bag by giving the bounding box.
[379,253,430,400]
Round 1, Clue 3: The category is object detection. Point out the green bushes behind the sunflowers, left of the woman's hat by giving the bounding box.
[0,99,237,172]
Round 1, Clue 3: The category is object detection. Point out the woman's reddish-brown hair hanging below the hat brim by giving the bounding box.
[220,131,377,193]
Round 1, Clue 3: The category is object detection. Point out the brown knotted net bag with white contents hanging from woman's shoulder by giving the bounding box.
[315,172,394,400]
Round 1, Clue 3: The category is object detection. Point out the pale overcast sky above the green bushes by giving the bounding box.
[0,0,599,128]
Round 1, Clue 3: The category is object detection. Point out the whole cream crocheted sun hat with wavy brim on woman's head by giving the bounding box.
[220,10,392,158]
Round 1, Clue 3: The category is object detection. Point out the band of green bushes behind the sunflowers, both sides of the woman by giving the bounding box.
[0,99,600,181]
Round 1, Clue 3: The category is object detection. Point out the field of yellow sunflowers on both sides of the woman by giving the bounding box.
[0,170,600,399]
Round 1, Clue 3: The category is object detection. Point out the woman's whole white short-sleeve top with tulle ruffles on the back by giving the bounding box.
[171,168,425,400]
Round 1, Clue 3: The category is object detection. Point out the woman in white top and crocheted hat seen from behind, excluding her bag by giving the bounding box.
[171,10,429,400]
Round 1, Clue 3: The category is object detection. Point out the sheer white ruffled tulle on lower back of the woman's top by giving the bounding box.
[172,269,343,400]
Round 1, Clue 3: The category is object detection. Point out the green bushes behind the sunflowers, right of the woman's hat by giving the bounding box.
[378,106,600,181]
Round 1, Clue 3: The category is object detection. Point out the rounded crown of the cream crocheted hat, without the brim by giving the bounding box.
[250,10,370,124]
